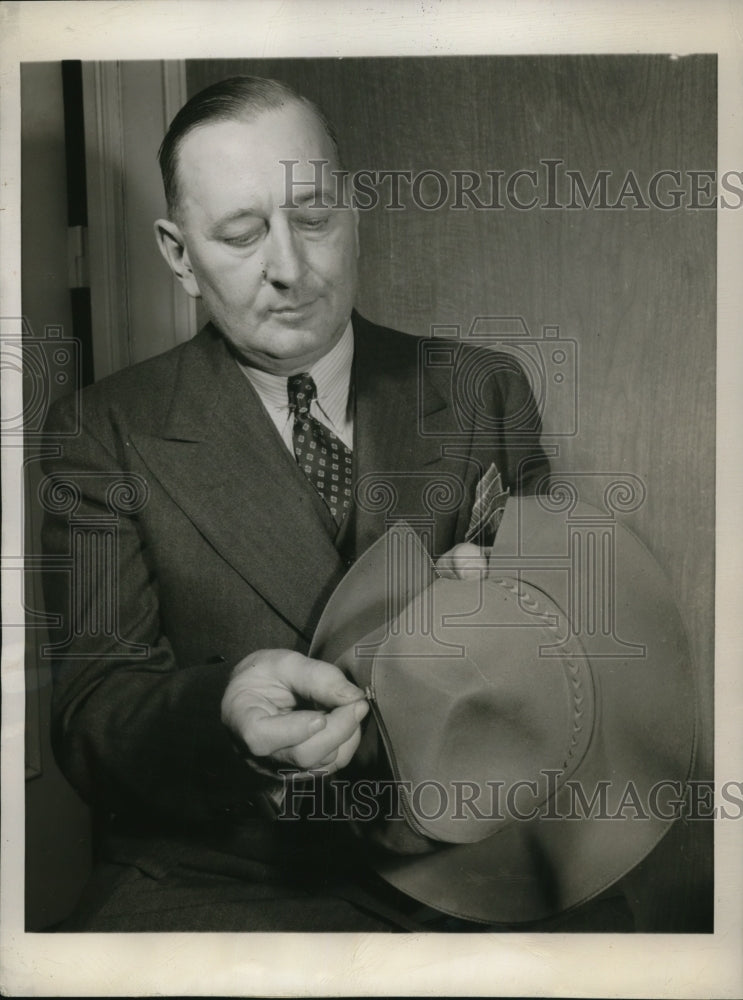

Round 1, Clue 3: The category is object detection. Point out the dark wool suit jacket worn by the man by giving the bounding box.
[44,315,547,876]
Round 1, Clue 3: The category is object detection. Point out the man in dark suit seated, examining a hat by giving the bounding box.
[45,77,547,931]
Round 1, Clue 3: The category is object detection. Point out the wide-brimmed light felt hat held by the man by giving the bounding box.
[311,497,696,924]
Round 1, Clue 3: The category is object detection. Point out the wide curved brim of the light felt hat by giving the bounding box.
[312,497,696,924]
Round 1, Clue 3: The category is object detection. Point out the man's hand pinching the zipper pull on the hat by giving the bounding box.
[222,649,369,777]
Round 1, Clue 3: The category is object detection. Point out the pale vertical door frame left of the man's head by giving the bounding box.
[83,60,197,380]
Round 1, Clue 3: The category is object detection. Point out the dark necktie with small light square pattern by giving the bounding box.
[287,372,353,525]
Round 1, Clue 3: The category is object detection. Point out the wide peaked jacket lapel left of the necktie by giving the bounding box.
[132,331,345,638]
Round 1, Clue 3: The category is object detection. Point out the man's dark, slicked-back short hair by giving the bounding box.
[157,76,340,218]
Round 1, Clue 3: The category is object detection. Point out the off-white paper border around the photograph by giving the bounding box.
[0,0,743,997]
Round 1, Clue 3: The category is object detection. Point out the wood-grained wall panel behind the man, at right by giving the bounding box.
[180,55,716,929]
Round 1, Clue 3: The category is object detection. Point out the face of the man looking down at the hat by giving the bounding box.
[158,103,358,374]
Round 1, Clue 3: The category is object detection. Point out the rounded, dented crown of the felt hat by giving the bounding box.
[364,578,594,843]
